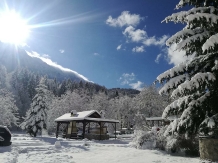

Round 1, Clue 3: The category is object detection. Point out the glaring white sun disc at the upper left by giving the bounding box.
[0,10,29,45]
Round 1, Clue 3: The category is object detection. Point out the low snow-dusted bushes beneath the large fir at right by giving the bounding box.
[132,126,199,156]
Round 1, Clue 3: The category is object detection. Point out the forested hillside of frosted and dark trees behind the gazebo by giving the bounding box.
[0,62,167,132]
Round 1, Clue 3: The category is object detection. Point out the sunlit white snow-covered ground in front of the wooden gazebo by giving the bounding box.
[0,134,203,163]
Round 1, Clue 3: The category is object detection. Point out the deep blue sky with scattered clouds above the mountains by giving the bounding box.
[1,0,187,89]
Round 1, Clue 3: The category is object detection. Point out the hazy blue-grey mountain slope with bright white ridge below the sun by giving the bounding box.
[0,42,88,81]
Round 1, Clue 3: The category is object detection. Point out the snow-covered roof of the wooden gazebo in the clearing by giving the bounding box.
[55,110,119,123]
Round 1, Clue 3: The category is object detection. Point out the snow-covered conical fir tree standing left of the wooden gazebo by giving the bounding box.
[21,78,52,137]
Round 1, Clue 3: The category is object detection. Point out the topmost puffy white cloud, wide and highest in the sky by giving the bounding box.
[106,11,143,27]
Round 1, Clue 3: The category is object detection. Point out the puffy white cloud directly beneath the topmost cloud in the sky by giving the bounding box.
[123,26,147,42]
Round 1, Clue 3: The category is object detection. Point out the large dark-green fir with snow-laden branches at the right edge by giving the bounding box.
[157,0,218,136]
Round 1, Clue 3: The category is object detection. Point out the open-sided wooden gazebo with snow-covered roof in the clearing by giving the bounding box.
[55,110,119,140]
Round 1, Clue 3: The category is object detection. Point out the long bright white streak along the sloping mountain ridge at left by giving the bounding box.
[26,51,89,81]
